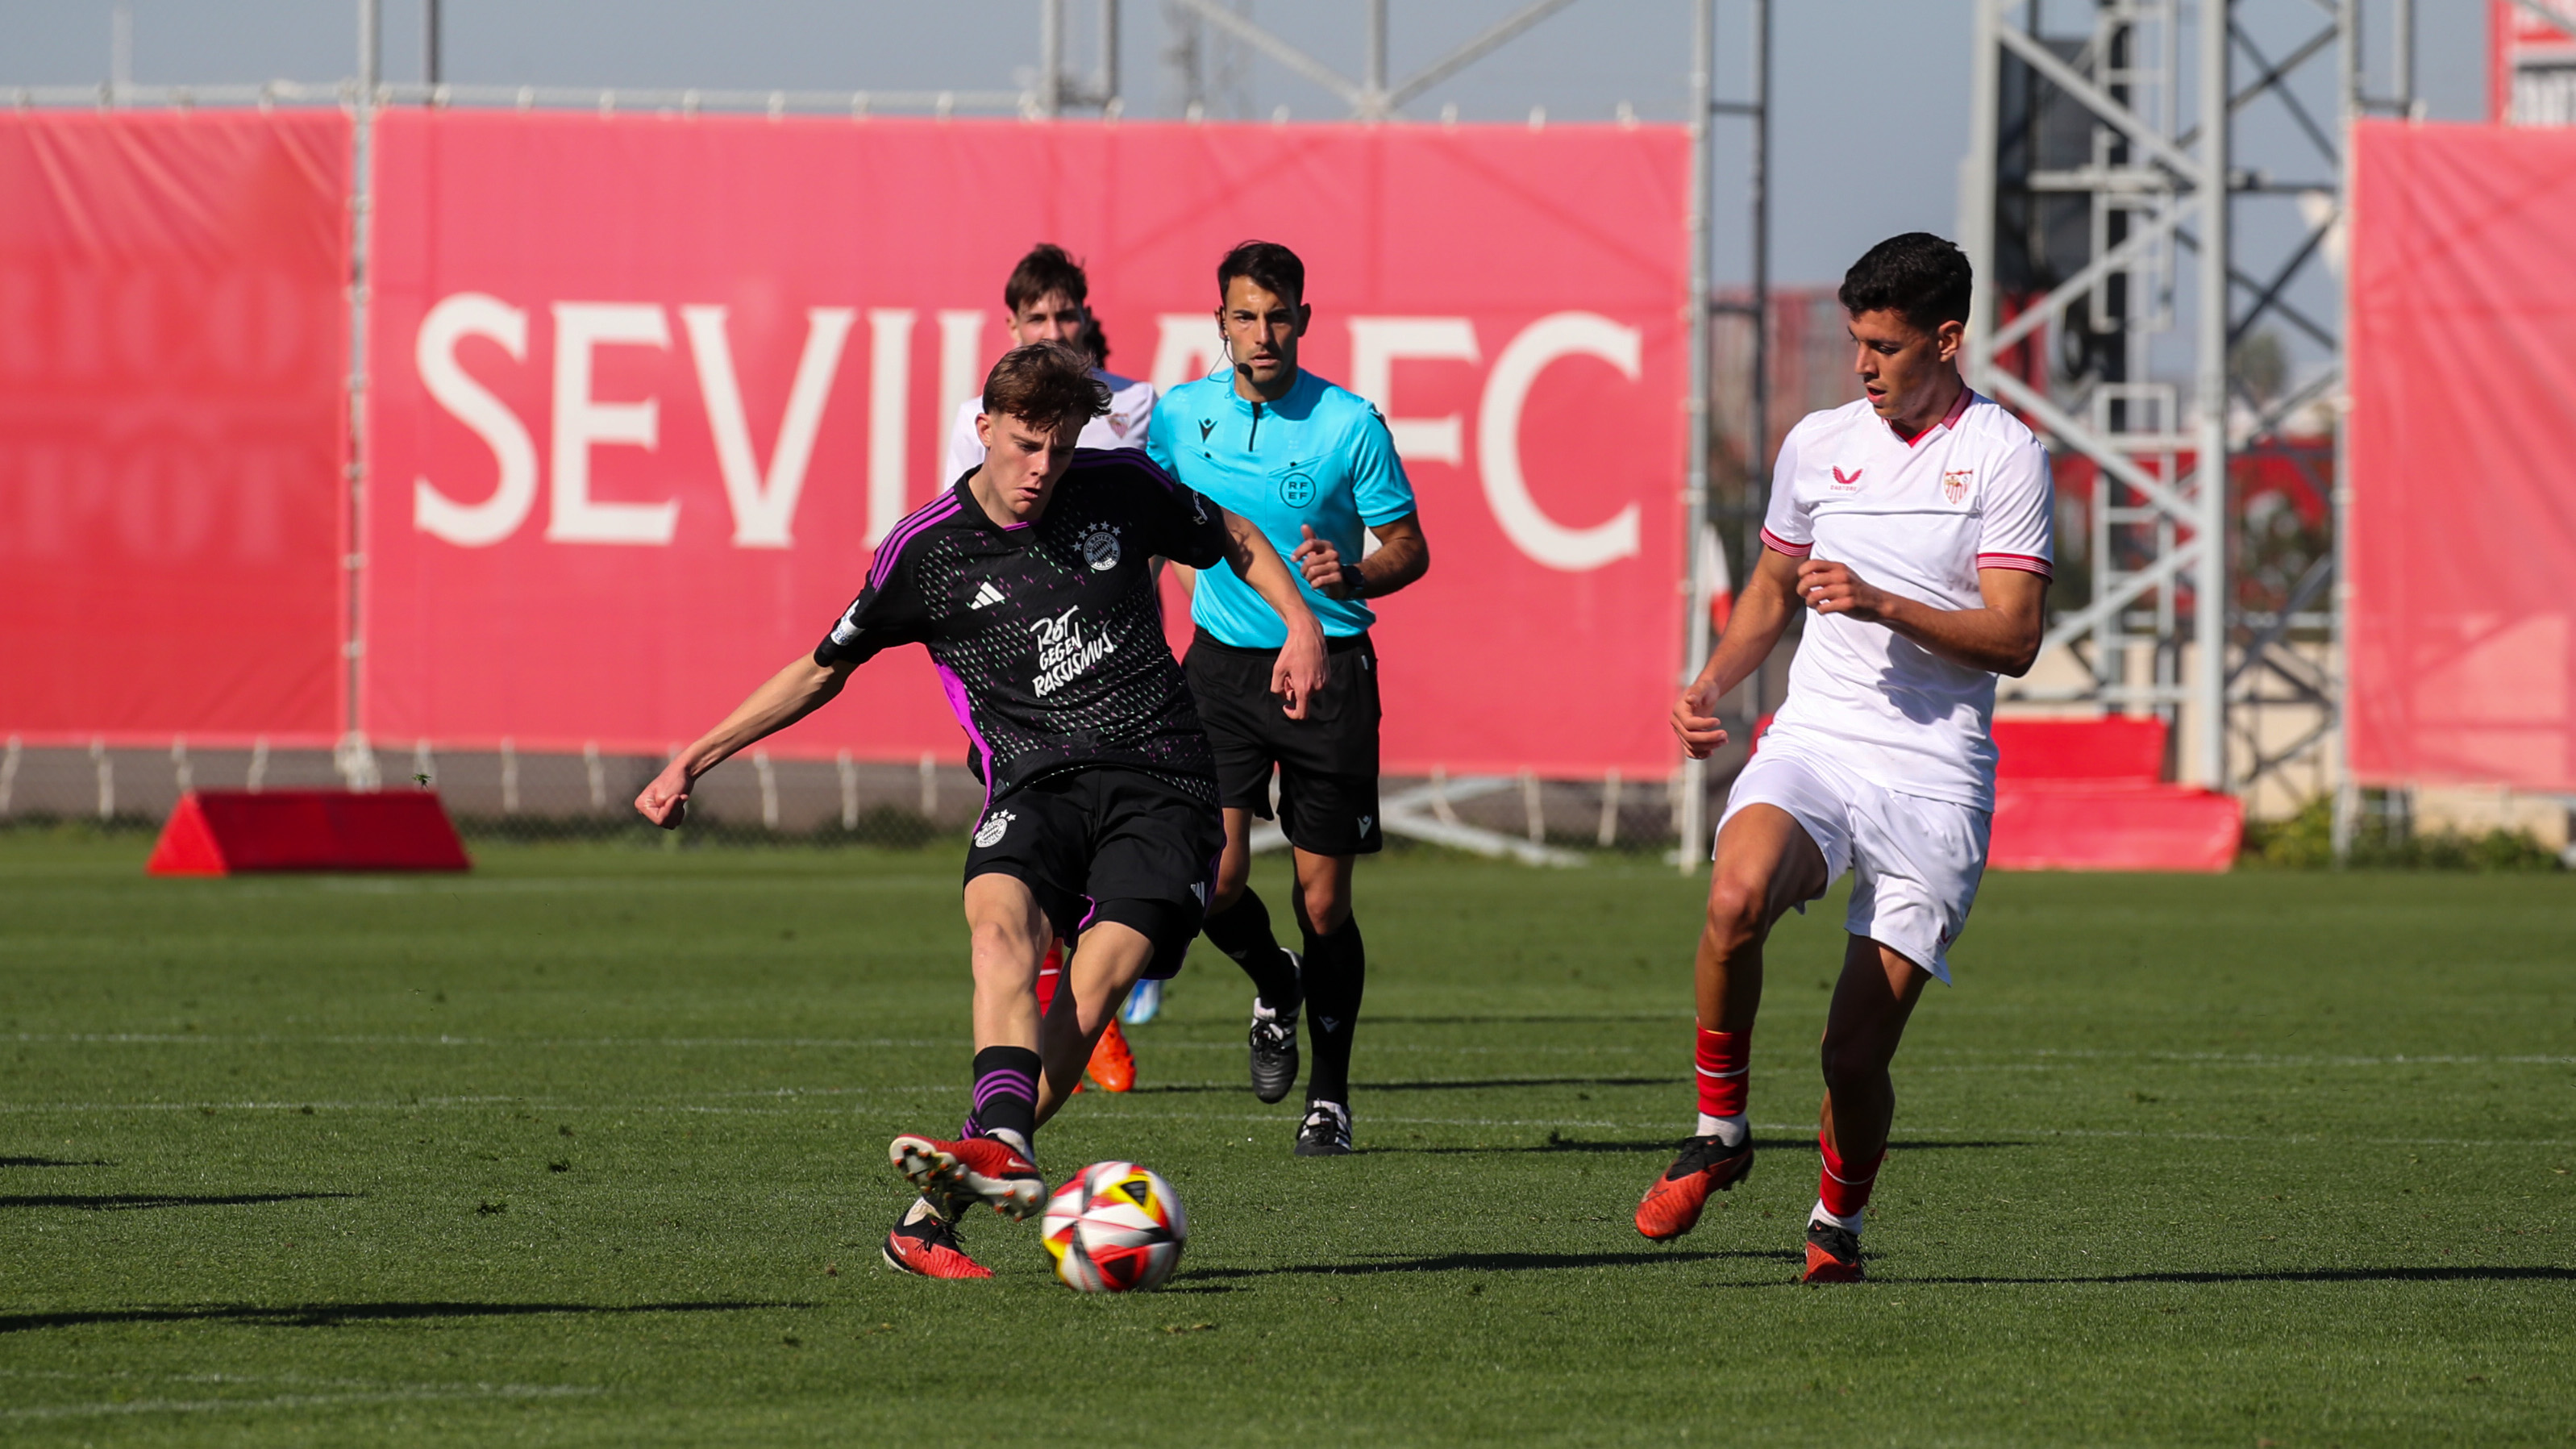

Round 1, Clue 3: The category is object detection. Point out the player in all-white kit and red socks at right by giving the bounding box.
[1636,232,2050,1284]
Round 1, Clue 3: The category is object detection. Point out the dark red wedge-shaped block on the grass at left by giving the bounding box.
[144,789,472,876]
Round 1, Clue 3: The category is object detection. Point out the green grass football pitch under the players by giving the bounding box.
[0,835,2576,1447]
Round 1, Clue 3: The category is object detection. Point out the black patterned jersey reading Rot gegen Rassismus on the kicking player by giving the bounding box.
[814,448,1226,802]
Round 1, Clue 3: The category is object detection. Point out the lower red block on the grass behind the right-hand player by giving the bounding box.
[1986,781,2246,872]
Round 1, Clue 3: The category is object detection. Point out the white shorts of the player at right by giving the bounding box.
[1718,740,1991,985]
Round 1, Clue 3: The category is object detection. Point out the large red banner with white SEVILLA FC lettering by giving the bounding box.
[363,110,1688,776]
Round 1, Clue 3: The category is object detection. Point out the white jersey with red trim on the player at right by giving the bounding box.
[1762,389,2053,810]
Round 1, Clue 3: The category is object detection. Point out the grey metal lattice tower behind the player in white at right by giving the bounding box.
[1960,0,2414,814]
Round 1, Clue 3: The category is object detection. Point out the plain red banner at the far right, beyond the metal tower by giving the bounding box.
[2344,121,2576,792]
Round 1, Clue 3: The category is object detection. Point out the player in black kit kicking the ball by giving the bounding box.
[636,343,1324,1279]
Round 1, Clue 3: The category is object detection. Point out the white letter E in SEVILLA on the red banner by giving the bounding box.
[546,302,680,547]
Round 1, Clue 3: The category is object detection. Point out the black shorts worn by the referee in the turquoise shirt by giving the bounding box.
[1185,629,1386,856]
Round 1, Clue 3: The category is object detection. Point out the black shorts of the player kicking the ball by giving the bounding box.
[966,766,1226,977]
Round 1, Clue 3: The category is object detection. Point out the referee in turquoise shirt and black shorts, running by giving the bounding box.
[1147,243,1432,1158]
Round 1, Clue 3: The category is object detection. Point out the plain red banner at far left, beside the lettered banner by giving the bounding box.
[0,110,351,743]
